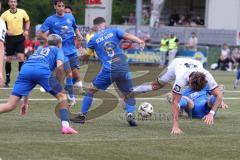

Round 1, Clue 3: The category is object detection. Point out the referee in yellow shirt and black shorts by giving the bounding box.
[1,0,30,87]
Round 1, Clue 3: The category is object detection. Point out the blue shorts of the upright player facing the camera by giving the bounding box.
[64,53,80,70]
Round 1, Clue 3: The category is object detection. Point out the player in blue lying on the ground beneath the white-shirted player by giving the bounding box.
[167,85,228,119]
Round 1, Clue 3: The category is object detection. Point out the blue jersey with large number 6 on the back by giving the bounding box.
[87,28,128,71]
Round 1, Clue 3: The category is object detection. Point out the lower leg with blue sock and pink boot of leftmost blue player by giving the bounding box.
[56,92,78,134]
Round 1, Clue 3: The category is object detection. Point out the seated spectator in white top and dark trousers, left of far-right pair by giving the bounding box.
[218,43,232,71]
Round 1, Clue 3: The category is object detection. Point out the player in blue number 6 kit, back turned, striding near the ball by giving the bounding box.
[71,17,145,126]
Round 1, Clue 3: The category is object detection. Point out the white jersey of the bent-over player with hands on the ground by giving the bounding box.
[158,58,218,94]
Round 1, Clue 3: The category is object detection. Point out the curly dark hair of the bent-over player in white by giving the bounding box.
[189,72,207,91]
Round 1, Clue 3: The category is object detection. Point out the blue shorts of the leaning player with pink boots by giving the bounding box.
[12,64,62,97]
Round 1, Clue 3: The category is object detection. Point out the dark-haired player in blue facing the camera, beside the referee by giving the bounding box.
[38,0,82,105]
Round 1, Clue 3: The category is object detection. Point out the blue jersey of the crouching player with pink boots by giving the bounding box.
[25,46,64,71]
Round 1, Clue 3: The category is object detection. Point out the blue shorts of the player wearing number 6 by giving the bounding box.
[92,68,133,94]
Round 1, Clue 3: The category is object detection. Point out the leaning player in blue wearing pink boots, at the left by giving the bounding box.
[0,34,78,134]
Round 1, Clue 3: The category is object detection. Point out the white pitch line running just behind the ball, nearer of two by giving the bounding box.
[0,97,240,101]
